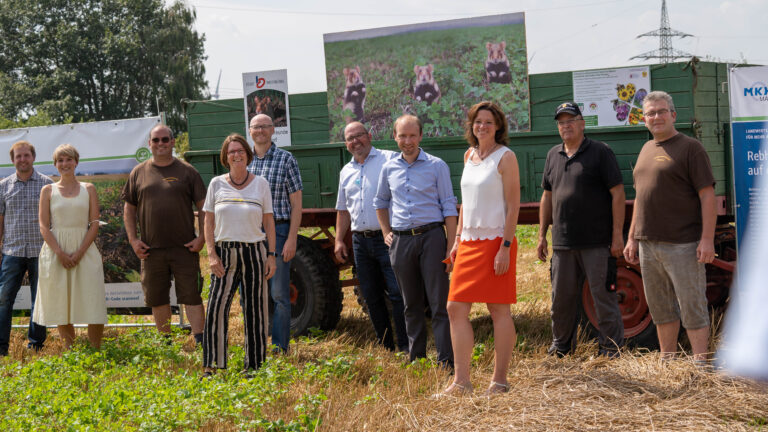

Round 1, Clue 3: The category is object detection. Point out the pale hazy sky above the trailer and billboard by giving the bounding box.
[183,0,768,98]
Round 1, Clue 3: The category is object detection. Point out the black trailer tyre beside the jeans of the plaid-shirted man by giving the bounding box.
[270,236,343,336]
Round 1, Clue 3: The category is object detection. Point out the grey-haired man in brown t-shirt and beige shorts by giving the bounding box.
[624,91,717,364]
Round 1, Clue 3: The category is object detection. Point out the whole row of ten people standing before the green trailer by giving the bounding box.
[0,92,716,386]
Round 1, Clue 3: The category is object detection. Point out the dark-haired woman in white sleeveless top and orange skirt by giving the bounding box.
[444,102,520,394]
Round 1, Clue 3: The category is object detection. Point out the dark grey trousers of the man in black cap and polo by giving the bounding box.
[551,247,624,352]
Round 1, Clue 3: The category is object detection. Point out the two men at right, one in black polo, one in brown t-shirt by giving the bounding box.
[538,91,717,367]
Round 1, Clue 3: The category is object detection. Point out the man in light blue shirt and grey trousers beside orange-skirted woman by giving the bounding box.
[373,115,458,368]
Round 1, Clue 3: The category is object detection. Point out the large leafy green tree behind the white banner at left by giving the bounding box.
[0,0,207,131]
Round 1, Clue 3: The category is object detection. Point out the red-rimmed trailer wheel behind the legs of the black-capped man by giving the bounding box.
[581,266,659,350]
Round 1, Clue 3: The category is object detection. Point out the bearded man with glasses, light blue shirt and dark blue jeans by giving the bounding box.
[334,122,408,352]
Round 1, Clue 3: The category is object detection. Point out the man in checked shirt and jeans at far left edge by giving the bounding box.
[0,141,53,356]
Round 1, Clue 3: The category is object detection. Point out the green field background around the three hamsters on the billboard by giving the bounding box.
[325,24,530,140]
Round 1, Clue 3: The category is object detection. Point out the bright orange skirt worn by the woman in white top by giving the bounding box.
[448,237,517,304]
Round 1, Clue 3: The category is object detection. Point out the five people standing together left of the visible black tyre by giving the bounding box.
[0,115,302,376]
